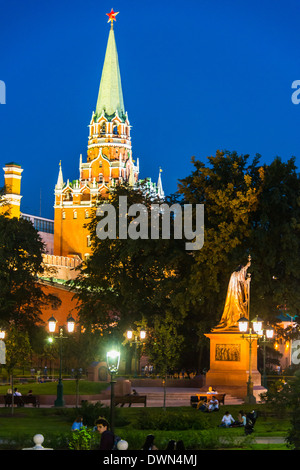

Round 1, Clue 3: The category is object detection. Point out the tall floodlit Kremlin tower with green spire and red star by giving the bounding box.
[54,10,163,260]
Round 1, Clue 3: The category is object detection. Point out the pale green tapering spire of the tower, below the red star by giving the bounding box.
[95,28,125,119]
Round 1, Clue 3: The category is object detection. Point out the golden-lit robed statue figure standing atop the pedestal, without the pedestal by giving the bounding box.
[215,255,251,330]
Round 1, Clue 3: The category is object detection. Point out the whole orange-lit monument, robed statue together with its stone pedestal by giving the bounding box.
[205,256,266,398]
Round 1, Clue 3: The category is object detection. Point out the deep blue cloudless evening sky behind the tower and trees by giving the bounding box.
[0,0,300,218]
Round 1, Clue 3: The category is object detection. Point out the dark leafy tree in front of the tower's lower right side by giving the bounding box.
[73,185,192,337]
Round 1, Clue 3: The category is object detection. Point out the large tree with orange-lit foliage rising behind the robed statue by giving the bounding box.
[179,151,300,328]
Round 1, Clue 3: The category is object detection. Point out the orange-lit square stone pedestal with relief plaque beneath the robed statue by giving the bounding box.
[205,330,261,395]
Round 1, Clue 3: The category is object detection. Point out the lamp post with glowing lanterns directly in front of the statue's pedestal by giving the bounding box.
[238,317,262,403]
